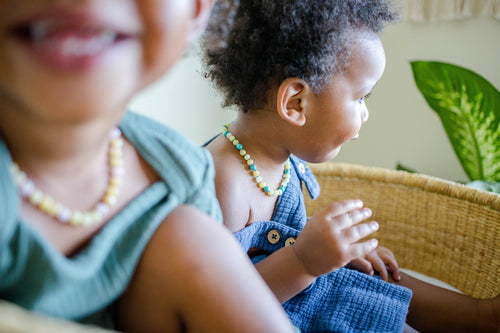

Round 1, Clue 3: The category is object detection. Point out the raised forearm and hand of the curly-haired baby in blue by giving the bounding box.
[256,200,378,302]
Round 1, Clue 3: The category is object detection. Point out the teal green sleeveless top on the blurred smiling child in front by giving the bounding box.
[0,112,222,328]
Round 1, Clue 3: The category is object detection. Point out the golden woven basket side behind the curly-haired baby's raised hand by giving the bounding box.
[305,162,500,298]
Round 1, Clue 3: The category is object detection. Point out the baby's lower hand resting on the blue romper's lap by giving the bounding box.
[347,246,401,281]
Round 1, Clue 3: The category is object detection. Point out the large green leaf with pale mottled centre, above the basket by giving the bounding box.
[411,61,500,182]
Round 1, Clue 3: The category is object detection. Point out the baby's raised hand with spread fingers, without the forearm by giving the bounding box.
[293,200,378,276]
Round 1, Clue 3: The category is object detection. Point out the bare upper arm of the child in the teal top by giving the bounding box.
[117,206,293,333]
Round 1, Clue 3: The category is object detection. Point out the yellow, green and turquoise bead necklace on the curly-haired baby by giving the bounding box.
[223,124,290,196]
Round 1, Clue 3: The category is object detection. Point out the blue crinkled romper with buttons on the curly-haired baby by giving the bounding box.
[234,156,412,333]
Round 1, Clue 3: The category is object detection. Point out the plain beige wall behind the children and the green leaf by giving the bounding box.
[131,17,500,181]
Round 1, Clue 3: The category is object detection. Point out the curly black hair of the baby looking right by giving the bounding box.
[202,0,398,112]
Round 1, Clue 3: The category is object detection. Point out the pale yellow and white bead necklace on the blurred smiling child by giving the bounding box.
[11,128,125,226]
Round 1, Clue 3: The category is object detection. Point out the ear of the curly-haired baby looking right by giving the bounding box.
[277,77,311,126]
